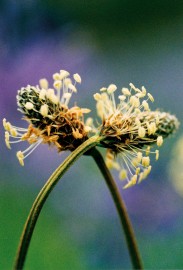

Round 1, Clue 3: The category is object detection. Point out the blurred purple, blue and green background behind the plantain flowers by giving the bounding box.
[0,0,183,270]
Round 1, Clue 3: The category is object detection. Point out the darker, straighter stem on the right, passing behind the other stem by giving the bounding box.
[90,148,143,269]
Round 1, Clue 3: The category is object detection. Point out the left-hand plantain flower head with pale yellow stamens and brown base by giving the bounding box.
[3,70,90,166]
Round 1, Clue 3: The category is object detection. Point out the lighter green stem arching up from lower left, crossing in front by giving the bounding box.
[14,136,101,270]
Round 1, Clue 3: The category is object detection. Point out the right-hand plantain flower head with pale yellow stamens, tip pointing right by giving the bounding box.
[94,83,178,188]
